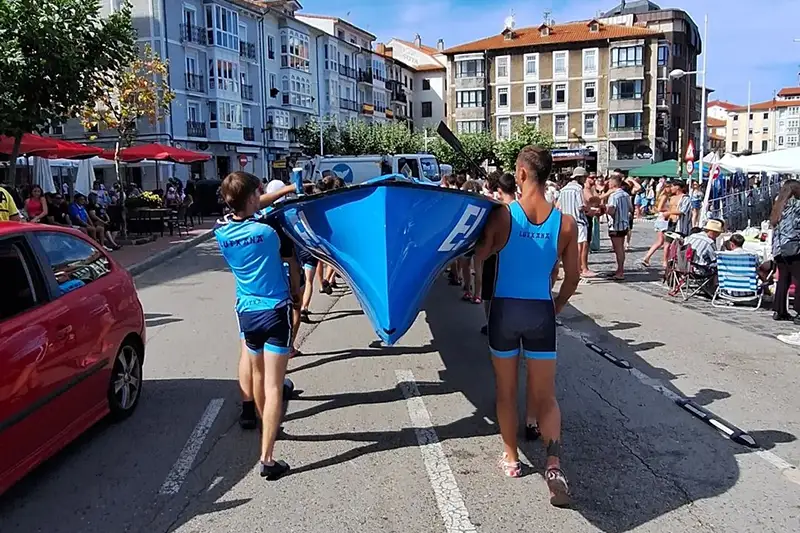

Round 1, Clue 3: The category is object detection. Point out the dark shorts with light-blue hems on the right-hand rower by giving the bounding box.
[488,298,557,360]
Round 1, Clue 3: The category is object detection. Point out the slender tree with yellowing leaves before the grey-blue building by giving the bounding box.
[82,45,175,179]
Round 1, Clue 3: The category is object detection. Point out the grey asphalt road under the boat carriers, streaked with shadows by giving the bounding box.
[0,239,800,533]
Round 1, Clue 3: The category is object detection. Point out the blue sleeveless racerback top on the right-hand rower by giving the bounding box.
[494,202,561,300]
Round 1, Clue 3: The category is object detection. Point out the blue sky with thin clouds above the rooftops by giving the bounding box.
[300,0,800,104]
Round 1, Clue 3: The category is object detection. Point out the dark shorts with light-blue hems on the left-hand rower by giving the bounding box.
[238,304,292,355]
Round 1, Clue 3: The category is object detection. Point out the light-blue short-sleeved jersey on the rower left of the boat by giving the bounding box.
[214,215,289,313]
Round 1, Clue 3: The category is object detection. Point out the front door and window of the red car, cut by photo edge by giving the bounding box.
[0,235,65,486]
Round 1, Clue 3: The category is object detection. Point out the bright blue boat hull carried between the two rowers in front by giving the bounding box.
[271,176,498,345]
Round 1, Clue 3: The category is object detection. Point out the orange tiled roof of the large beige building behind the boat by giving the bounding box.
[444,21,660,55]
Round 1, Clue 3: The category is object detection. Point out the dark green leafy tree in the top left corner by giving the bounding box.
[0,0,136,176]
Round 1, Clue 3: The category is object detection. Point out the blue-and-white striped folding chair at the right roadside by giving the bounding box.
[711,252,765,309]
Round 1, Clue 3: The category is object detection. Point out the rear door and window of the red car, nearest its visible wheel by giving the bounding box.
[35,231,119,430]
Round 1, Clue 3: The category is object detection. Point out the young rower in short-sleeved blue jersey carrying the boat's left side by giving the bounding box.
[214,172,299,480]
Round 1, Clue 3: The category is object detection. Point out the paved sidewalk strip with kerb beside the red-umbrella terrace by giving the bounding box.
[112,220,214,276]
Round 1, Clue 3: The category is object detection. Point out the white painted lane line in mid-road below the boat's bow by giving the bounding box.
[395,370,478,533]
